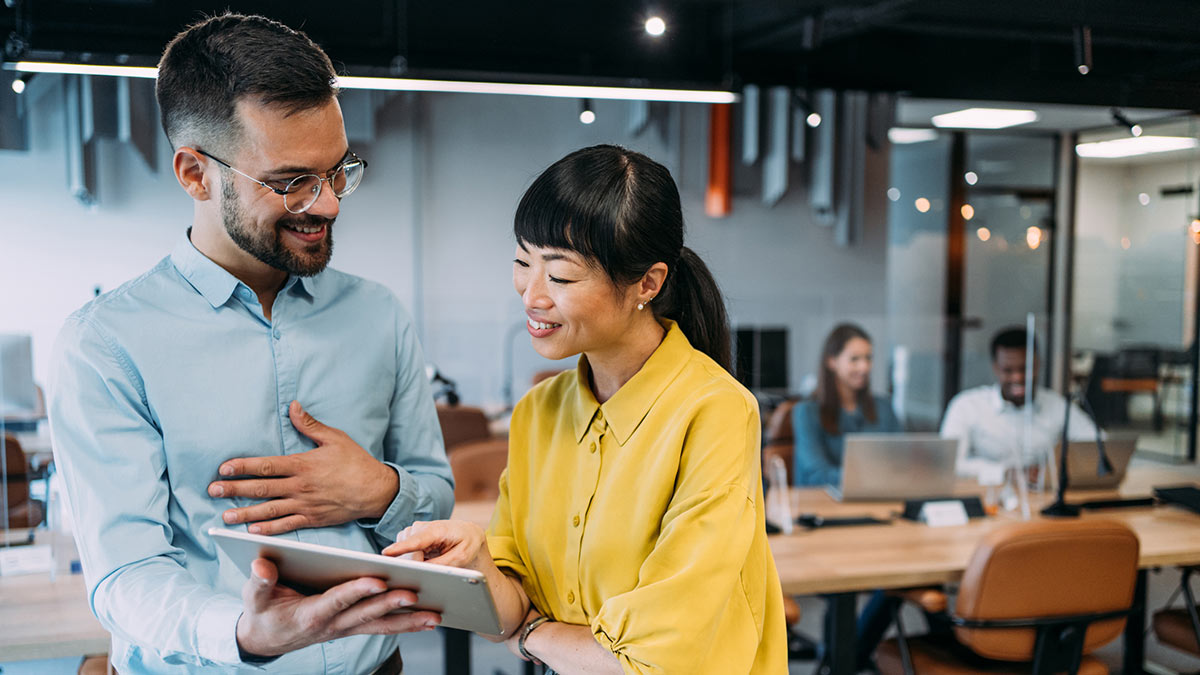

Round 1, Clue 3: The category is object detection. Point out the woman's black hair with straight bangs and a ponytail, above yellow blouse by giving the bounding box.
[512,145,732,370]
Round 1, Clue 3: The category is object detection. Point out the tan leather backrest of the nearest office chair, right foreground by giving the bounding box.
[955,519,1139,661]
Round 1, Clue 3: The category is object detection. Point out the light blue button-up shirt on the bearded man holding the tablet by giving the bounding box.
[50,230,454,674]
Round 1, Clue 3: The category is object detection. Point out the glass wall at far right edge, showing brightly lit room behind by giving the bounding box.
[1072,118,1200,461]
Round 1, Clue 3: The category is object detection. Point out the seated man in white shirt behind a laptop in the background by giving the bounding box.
[941,328,1097,477]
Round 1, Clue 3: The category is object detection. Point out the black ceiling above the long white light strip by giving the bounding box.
[7,0,1200,109]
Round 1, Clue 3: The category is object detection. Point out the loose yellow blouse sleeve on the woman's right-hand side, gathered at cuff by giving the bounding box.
[592,389,763,674]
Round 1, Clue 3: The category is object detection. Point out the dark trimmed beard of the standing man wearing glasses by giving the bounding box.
[221,180,334,276]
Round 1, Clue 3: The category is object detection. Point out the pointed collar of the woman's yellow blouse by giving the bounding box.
[575,319,694,446]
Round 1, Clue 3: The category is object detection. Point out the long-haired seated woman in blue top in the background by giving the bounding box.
[792,323,901,485]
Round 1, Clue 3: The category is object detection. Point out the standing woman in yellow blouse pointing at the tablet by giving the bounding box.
[384,145,787,675]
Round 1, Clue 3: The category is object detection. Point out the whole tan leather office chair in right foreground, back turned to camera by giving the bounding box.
[876,519,1138,675]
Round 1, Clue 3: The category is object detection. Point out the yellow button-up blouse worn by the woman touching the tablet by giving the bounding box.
[487,322,787,675]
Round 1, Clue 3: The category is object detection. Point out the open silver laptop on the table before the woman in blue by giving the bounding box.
[828,434,959,502]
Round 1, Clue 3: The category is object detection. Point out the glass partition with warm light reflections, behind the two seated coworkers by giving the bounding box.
[887,132,1057,430]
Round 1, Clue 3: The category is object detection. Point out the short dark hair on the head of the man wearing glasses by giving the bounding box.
[155,12,337,151]
